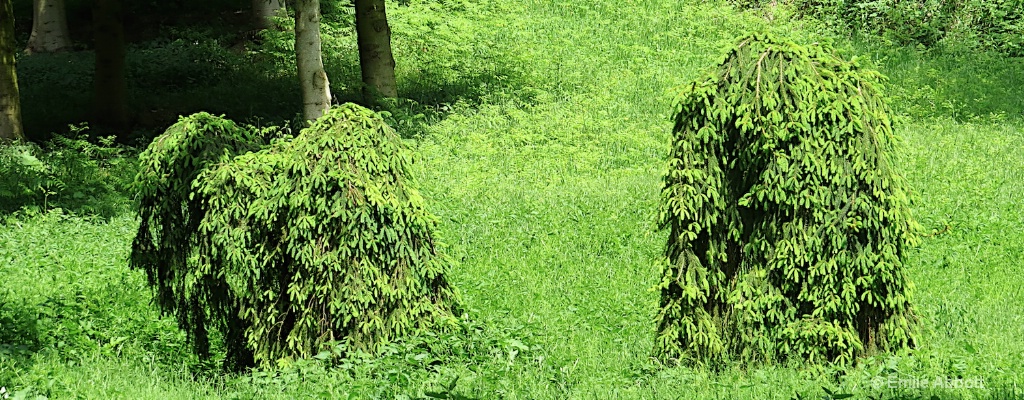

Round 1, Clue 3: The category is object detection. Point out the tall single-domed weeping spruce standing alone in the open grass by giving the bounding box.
[655,34,919,364]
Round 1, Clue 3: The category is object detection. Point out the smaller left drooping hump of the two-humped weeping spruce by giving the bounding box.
[130,113,260,363]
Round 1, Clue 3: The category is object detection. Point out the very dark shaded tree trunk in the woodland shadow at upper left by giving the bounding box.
[92,0,128,139]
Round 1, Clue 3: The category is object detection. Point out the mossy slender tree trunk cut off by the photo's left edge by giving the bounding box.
[0,0,25,142]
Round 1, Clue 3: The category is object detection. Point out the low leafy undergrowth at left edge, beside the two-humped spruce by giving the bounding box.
[0,128,135,217]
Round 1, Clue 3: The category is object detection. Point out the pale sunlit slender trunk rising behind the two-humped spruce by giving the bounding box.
[295,0,331,121]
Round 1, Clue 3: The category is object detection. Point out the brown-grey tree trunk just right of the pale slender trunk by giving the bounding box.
[355,0,398,104]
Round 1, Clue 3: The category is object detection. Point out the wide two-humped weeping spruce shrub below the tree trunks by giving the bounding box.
[133,104,458,367]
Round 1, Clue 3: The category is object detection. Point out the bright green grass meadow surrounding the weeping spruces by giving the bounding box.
[0,0,1024,399]
